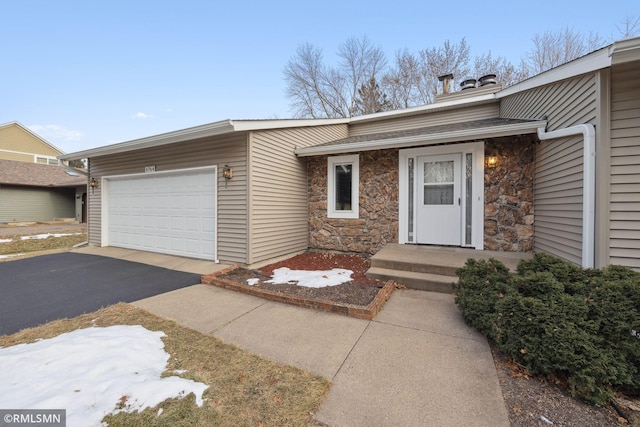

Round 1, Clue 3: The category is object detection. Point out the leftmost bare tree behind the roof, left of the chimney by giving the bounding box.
[284,37,386,118]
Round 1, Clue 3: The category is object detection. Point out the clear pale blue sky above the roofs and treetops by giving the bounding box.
[0,0,640,152]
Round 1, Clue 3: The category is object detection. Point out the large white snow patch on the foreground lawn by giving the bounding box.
[0,325,209,427]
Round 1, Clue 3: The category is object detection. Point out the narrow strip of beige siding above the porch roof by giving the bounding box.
[349,103,499,136]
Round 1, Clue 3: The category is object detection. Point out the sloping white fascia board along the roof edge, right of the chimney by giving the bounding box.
[496,46,611,99]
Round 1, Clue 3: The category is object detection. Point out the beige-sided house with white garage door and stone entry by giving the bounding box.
[60,38,640,269]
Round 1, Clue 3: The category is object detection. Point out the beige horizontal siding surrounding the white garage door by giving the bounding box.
[88,133,248,263]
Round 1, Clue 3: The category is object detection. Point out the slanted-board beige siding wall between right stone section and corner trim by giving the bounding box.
[500,74,597,264]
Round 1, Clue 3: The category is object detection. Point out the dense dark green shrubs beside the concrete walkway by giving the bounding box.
[455,254,640,404]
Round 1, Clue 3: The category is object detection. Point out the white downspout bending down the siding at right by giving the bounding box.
[538,123,596,268]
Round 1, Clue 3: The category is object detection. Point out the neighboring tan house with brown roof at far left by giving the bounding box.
[0,122,87,223]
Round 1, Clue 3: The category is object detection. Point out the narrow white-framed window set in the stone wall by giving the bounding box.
[327,154,360,218]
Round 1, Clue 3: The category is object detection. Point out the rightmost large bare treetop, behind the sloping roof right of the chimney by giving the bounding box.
[526,27,605,75]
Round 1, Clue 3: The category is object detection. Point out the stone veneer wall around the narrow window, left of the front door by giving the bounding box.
[307,150,398,254]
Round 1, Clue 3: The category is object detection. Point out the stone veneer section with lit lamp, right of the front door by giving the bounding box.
[484,135,536,252]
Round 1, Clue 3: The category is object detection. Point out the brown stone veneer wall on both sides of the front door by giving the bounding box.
[307,135,536,254]
